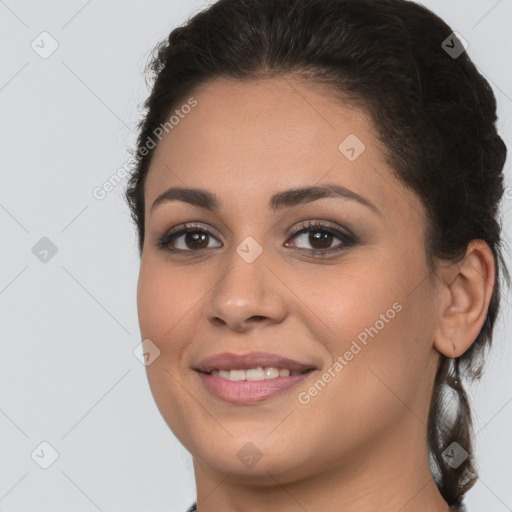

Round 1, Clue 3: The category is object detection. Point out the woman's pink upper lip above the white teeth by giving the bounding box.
[194,352,314,373]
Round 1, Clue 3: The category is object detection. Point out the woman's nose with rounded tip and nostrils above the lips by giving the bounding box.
[205,245,287,332]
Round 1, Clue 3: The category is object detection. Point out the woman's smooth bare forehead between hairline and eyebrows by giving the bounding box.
[145,78,424,220]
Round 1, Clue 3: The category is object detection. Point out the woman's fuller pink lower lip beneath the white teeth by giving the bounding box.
[198,371,313,404]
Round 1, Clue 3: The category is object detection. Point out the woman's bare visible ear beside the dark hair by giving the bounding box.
[434,240,495,358]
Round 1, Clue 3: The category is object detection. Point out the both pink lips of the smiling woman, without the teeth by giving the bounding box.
[194,352,315,405]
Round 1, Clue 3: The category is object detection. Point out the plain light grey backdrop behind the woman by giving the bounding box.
[0,0,512,512]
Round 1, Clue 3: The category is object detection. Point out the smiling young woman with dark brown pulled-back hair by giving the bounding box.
[126,0,508,512]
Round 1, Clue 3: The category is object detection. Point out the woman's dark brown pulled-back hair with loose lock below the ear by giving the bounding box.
[126,0,510,505]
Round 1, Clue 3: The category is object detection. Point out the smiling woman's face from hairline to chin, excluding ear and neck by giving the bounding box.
[138,79,439,483]
